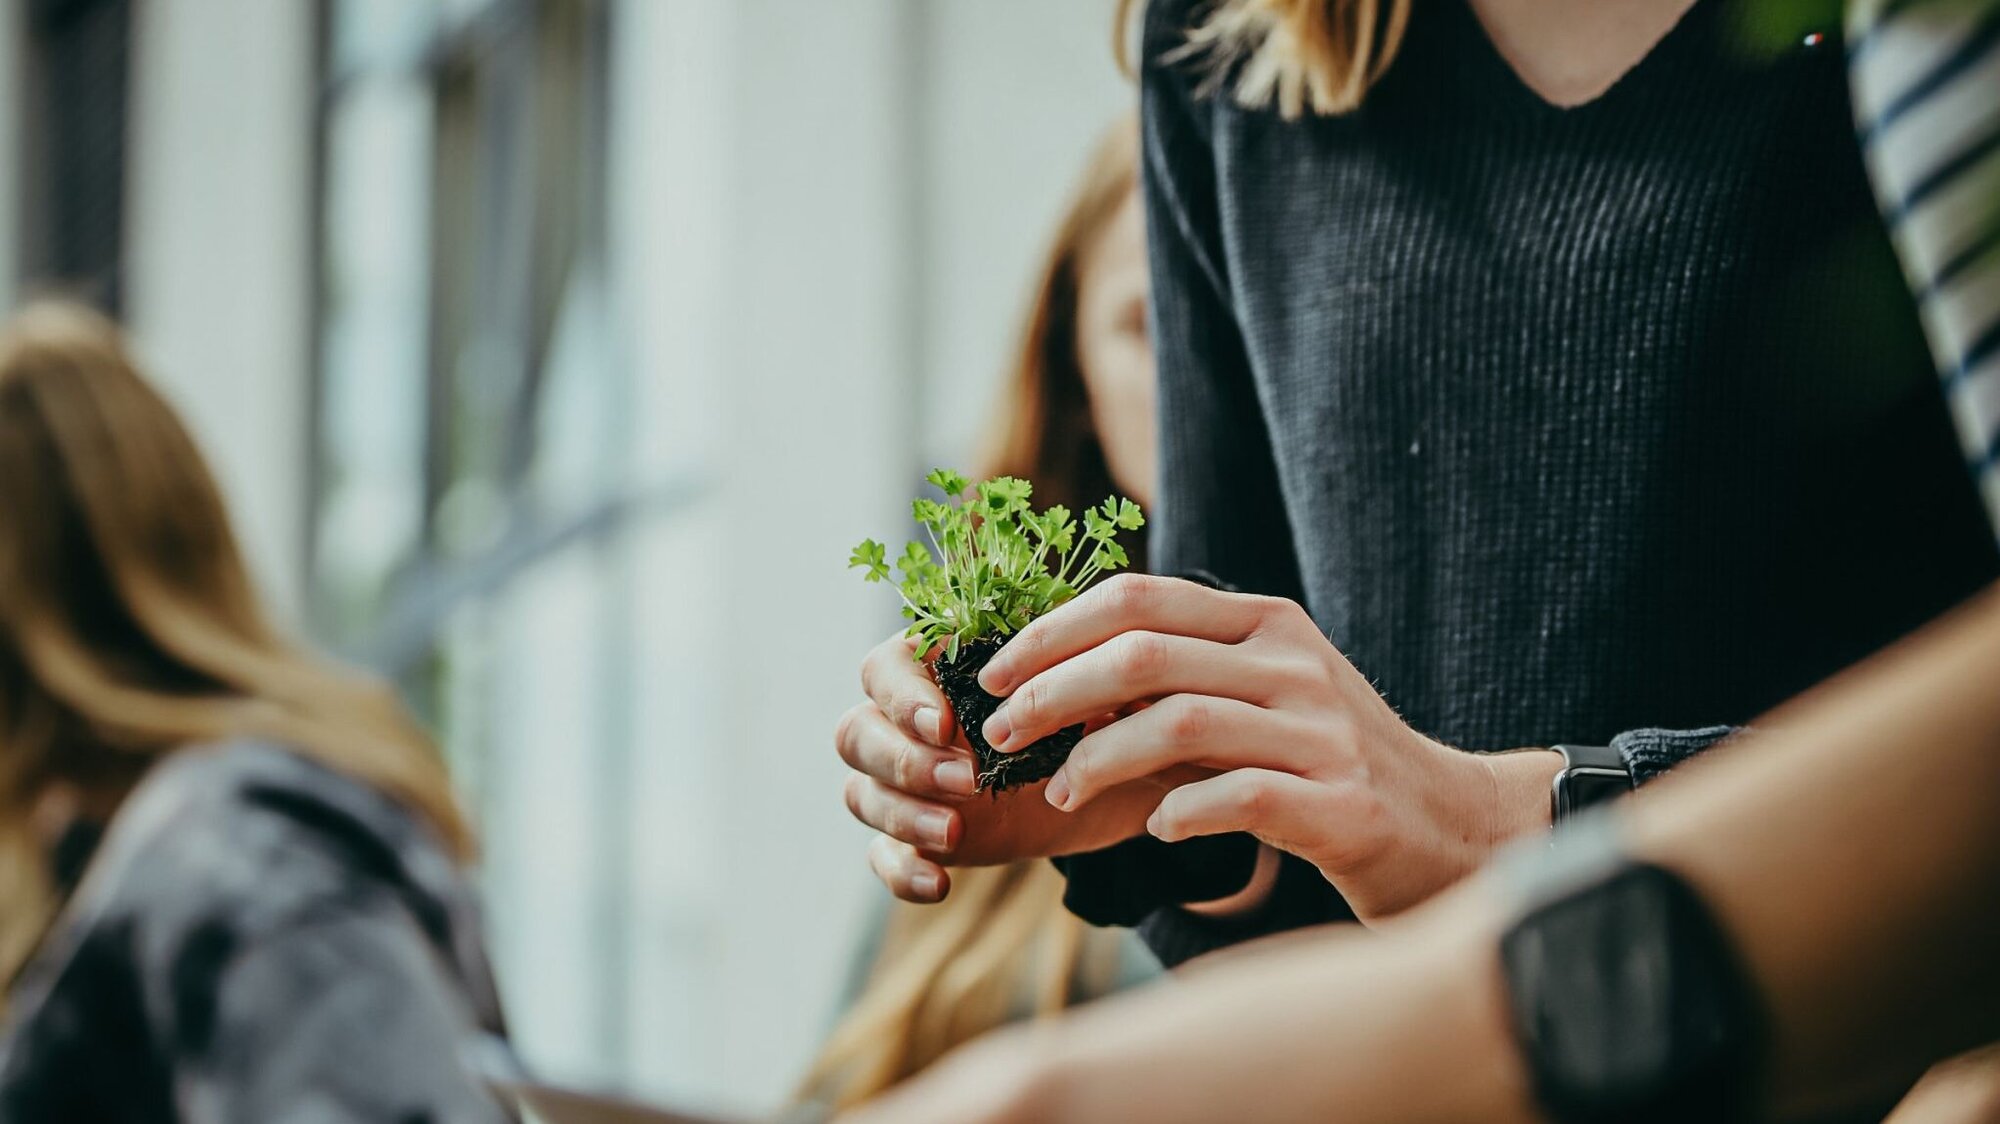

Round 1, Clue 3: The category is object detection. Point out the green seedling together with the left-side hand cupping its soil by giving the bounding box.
[834,470,1168,902]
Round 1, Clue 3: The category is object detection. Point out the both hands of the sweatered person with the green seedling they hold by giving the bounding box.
[838,474,1556,920]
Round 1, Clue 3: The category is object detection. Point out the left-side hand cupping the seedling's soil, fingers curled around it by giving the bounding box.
[834,634,1206,902]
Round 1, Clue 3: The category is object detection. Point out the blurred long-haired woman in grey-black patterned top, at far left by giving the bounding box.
[0,304,506,1124]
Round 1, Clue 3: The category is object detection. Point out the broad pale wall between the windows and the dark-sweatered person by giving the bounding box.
[612,0,1130,1106]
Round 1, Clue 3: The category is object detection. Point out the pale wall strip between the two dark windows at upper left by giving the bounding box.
[126,0,314,620]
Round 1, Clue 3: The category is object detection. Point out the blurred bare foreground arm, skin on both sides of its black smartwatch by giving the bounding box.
[840,580,2000,1124]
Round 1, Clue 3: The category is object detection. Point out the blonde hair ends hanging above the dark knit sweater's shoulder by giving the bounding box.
[1116,0,1412,120]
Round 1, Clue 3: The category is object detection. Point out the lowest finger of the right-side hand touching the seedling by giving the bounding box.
[1146,768,1368,870]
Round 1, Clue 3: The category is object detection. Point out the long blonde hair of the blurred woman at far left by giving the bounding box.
[0,302,472,974]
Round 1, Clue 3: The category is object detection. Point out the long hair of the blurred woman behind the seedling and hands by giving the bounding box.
[798,116,1140,1108]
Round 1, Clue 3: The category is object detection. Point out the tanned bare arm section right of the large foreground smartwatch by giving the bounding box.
[1630,594,2000,1112]
